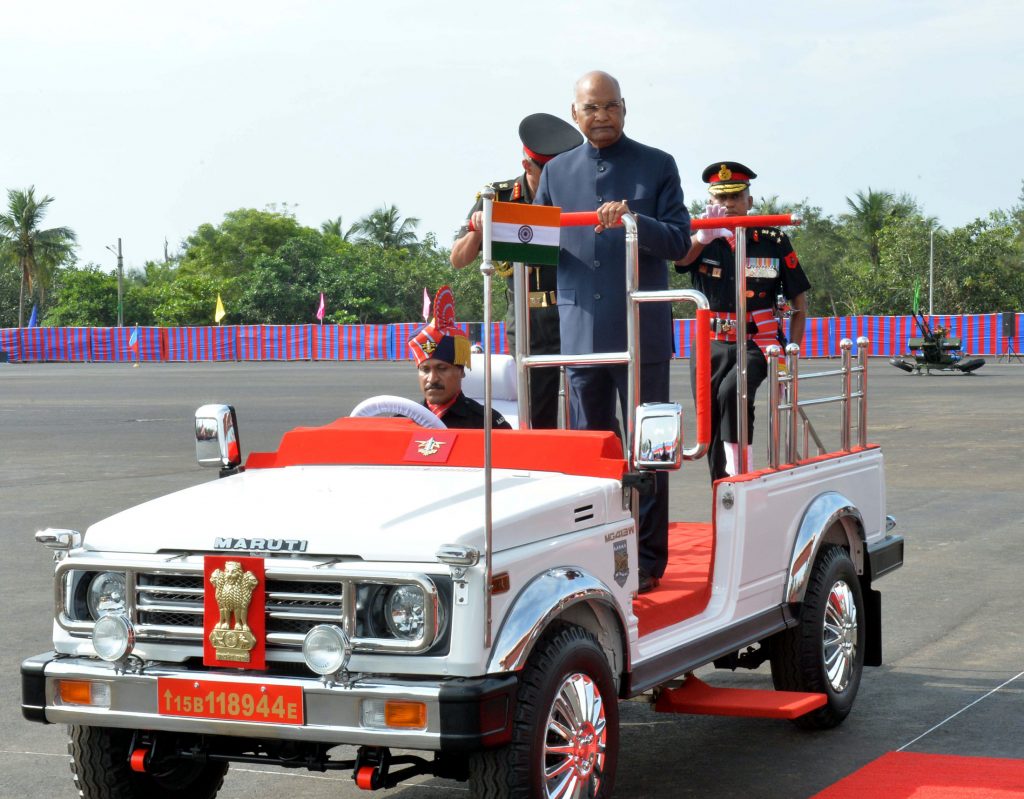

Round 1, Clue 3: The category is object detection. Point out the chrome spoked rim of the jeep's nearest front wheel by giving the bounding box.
[544,672,608,799]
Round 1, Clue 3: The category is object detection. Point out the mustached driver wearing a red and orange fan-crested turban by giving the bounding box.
[409,286,512,430]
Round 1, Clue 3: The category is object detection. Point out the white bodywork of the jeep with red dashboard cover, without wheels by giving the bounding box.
[23,208,902,796]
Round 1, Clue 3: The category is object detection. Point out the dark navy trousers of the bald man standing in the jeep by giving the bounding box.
[567,361,669,578]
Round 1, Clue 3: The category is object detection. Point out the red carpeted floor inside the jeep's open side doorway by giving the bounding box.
[633,521,715,635]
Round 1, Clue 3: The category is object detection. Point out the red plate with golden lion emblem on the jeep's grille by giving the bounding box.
[203,557,266,669]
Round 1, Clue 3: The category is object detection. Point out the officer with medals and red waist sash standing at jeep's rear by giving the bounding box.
[676,161,811,480]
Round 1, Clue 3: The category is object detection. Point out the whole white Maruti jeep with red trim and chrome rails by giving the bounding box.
[22,208,902,799]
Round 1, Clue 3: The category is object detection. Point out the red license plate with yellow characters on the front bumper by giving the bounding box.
[157,677,303,724]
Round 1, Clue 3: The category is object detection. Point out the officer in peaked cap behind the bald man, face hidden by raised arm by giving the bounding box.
[451,114,583,429]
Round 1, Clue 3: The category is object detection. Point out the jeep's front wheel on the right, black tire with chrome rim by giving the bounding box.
[469,625,618,799]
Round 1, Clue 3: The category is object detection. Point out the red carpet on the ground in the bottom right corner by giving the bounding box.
[812,752,1024,799]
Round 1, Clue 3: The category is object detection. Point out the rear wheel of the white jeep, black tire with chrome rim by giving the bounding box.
[771,546,867,729]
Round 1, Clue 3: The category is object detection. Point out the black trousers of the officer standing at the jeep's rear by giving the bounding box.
[690,341,768,481]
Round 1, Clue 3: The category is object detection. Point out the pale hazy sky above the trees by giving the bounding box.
[0,0,1024,266]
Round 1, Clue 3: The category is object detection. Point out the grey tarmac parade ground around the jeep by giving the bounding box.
[0,359,1024,799]
